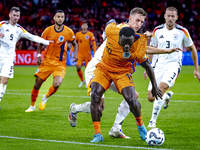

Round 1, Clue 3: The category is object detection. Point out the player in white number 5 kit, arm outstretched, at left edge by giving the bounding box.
[0,7,49,105]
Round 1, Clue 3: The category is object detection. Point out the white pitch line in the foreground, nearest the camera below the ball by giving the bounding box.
[0,135,171,150]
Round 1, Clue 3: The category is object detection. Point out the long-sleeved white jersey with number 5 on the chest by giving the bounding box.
[0,21,49,59]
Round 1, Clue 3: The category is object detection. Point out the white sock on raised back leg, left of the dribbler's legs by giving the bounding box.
[72,102,91,113]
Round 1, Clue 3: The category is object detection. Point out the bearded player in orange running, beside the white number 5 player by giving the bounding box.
[26,10,78,112]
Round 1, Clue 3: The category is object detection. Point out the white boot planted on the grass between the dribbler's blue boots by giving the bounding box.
[108,127,130,139]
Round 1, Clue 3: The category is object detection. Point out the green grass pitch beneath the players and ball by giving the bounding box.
[0,66,200,150]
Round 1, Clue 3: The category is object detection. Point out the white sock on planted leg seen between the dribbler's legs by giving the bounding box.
[113,100,130,129]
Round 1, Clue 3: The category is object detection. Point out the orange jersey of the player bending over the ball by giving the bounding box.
[97,23,147,73]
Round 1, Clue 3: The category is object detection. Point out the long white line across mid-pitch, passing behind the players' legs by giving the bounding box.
[5,92,200,103]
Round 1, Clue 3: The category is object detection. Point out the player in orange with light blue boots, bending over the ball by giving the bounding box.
[90,22,162,142]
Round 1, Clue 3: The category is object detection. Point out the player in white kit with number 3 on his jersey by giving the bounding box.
[144,7,200,127]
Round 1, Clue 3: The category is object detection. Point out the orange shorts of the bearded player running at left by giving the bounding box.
[35,60,67,81]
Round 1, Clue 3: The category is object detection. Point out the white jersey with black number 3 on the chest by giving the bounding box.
[150,24,193,67]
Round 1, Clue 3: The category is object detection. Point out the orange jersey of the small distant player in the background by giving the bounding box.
[76,31,96,57]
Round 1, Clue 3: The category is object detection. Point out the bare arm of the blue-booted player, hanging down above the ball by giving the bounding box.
[140,60,162,99]
